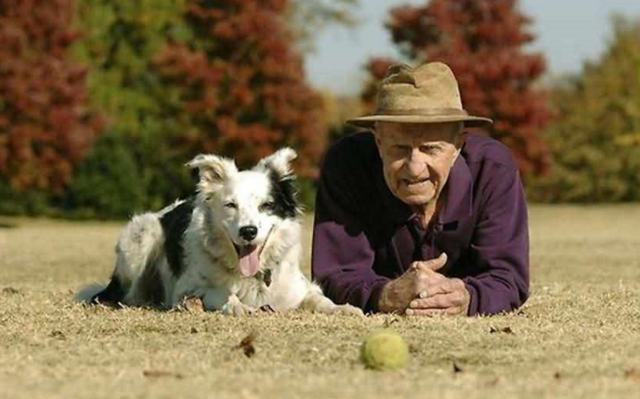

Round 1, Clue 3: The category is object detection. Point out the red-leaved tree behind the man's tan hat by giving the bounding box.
[363,0,550,176]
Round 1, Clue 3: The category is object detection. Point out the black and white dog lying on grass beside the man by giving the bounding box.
[78,148,362,315]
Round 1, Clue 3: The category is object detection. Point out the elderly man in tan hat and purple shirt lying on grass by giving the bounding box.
[312,62,529,315]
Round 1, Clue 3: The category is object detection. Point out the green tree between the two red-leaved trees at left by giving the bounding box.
[74,0,193,209]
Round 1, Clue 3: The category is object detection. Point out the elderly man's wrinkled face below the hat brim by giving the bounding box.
[375,122,462,208]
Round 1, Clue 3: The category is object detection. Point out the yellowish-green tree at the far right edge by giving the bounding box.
[530,16,640,202]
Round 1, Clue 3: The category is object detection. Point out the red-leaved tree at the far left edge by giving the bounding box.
[0,0,101,192]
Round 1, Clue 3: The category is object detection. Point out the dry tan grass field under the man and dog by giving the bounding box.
[0,206,640,399]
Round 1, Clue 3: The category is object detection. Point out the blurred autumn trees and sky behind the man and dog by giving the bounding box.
[0,0,640,219]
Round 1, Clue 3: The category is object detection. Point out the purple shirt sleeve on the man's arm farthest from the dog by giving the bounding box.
[463,167,529,316]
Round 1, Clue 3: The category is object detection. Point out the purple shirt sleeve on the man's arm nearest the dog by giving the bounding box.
[311,146,389,312]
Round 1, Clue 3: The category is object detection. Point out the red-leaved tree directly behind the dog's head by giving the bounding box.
[155,0,326,176]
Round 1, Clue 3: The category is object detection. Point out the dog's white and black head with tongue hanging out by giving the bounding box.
[187,148,298,276]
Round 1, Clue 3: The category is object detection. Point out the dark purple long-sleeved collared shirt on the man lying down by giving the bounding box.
[311,133,529,315]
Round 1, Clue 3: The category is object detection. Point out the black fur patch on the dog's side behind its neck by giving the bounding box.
[160,198,194,277]
